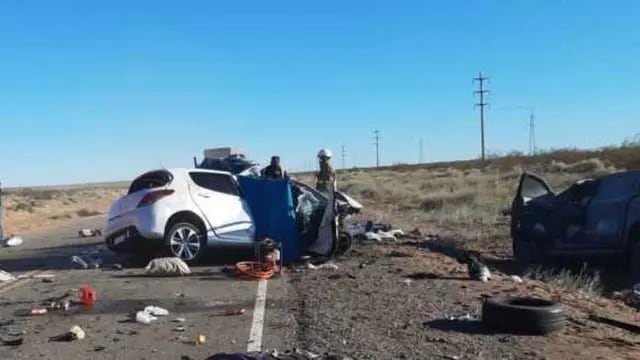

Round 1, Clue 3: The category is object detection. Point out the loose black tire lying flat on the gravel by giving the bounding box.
[482,297,566,335]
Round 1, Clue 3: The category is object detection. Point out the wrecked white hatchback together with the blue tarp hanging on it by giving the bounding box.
[105,159,362,263]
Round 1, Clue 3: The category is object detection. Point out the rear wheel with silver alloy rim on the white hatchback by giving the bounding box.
[164,222,206,265]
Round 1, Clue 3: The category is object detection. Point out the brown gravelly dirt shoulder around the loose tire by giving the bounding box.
[291,239,640,360]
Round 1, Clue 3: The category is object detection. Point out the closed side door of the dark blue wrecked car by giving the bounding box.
[584,172,638,248]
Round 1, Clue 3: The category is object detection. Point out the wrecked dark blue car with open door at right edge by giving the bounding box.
[511,171,640,274]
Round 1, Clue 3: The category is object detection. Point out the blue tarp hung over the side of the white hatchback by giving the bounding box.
[238,176,302,262]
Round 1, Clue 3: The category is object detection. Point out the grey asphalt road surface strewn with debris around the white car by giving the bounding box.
[0,217,296,359]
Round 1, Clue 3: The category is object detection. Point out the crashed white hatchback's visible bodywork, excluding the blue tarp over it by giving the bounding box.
[105,168,361,263]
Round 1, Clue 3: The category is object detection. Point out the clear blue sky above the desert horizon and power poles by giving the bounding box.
[0,0,640,186]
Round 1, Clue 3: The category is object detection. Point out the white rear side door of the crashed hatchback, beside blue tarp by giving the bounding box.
[189,171,254,243]
